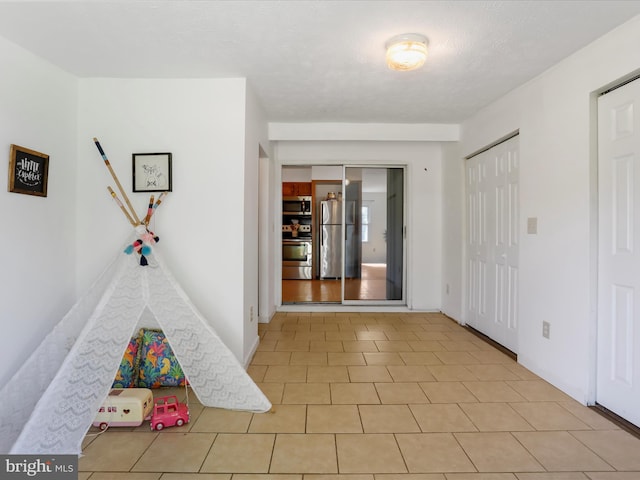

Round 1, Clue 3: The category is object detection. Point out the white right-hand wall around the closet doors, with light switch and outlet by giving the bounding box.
[452,17,640,402]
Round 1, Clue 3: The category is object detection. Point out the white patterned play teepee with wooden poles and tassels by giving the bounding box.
[0,140,271,454]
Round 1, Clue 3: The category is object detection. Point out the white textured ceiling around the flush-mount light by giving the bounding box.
[0,0,640,123]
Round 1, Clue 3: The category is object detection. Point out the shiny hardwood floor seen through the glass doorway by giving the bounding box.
[282,263,386,304]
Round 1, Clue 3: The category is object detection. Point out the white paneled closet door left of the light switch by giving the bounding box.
[466,135,520,353]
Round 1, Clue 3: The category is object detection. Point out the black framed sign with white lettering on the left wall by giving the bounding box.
[9,145,49,197]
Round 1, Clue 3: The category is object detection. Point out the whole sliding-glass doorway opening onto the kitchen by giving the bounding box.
[282,165,406,305]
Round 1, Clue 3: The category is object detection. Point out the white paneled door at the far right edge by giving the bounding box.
[596,80,640,426]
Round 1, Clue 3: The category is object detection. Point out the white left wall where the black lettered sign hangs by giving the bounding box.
[0,38,77,388]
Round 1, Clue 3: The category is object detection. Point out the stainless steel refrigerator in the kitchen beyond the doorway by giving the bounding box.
[319,200,360,278]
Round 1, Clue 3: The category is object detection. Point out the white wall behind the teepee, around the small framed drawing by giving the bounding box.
[76,79,251,361]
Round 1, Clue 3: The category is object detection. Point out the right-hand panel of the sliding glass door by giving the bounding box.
[343,166,405,304]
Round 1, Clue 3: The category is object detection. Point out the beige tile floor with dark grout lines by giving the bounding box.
[79,313,640,480]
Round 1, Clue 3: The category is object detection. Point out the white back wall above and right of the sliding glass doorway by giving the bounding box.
[274,141,442,310]
